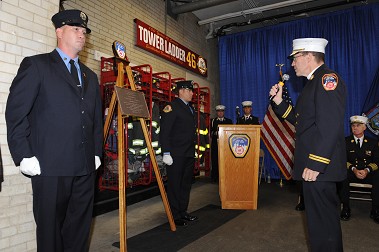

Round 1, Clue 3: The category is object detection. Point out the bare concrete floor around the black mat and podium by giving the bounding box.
[90,179,379,252]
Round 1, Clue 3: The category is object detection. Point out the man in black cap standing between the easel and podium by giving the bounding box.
[160,81,197,226]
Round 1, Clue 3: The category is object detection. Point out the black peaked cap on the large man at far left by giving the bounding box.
[51,10,91,34]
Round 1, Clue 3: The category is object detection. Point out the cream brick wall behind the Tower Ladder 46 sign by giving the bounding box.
[0,0,219,252]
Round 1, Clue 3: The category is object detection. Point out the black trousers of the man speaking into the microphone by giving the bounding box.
[303,181,343,252]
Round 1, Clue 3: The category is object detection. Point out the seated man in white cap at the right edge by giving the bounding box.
[340,115,379,223]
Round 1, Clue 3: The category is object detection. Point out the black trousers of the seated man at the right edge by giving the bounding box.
[339,170,379,210]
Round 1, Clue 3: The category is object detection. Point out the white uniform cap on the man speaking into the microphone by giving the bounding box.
[288,38,328,58]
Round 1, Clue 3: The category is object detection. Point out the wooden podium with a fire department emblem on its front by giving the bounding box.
[218,125,261,209]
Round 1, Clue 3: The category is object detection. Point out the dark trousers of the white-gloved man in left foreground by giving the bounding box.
[32,172,96,252]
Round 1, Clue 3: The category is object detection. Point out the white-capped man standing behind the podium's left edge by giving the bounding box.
[211,105,233,182]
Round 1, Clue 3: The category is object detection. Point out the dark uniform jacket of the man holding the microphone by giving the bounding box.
[273,65,346,181]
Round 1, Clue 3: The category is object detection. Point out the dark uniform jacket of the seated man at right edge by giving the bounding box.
[346,135,379,171]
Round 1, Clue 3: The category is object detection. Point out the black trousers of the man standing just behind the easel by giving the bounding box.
[167,156,195,219]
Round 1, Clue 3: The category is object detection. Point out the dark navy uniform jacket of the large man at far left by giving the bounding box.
[5,50,103,176]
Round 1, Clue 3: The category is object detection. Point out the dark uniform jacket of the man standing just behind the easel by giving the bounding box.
[159,98,196,157]
